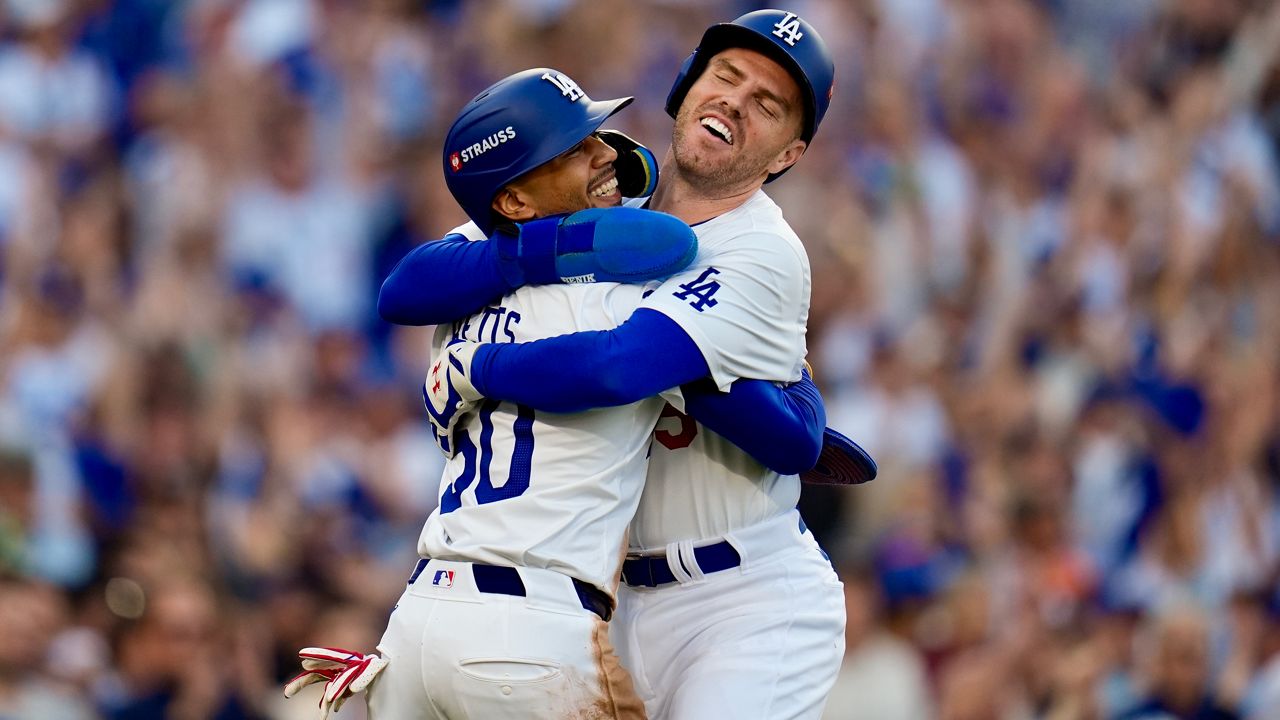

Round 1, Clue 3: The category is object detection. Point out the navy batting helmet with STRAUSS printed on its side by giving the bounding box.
[444,68,631,234]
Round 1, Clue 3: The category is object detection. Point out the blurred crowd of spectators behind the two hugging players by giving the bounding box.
[0,0,1280,720]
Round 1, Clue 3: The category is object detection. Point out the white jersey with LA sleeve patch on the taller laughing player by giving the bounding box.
[631,191,810,551]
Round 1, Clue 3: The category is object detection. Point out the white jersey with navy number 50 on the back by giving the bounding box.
[417,224,664,593]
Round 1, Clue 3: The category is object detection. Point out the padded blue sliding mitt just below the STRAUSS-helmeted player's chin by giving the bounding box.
[492,208,698,287]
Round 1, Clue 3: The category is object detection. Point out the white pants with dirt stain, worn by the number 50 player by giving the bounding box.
[367,560,645,720]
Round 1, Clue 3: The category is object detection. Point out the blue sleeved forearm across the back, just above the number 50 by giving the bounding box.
[471,309,710,413]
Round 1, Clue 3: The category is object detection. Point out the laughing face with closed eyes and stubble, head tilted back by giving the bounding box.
[672,47,805,190]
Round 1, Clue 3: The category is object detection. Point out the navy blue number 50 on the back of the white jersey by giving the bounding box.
[440,400,534,515]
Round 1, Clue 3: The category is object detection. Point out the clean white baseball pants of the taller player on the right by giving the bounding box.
[609,511,845,720]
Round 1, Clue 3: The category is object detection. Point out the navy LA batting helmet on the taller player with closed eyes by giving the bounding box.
[667,10,836,182]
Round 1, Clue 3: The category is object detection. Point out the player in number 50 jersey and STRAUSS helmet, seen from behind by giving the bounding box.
[287,68,824,717]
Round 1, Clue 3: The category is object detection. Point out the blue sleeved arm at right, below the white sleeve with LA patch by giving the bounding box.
[681,372,827,475]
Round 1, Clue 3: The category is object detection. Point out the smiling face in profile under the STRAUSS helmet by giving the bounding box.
[493,133,622,222]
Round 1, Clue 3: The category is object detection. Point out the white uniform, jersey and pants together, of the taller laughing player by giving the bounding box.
[609,192,845,720]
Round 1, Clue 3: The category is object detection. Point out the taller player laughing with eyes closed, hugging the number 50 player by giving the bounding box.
[407,10,845,720]
